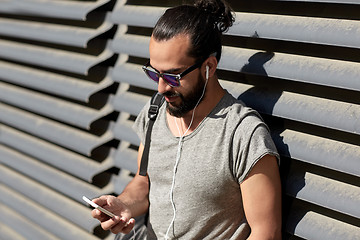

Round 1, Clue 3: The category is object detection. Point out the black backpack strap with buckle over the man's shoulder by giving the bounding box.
[139,93,165,176]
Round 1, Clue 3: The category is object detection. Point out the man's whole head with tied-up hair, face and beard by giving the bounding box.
[145,0,234,117]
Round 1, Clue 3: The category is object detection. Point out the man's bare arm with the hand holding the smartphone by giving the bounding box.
[91,144,149,234]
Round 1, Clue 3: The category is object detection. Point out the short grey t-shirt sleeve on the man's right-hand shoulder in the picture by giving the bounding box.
[232,115,280,184]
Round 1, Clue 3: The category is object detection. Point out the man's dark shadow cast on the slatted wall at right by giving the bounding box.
[238,52,305,239]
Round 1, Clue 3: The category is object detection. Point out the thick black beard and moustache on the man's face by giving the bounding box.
[163,74,205,118]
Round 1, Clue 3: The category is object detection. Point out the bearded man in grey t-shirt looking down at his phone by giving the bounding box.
[92,0,281,240]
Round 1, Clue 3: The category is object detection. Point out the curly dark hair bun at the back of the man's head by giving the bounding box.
[194,0,235,33]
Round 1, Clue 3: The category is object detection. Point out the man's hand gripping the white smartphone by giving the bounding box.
[91,195,135,234]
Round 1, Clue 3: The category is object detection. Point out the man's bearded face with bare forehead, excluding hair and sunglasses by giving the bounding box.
[149,34,208,117]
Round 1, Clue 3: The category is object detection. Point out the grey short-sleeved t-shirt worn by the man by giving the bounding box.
[134,92,279,240]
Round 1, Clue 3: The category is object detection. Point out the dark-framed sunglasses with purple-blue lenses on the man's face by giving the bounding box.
[142,60,204,87]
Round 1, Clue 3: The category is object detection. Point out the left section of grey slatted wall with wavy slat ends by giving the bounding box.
[0,0,131,239]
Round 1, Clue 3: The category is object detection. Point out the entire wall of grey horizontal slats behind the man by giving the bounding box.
[0,0,360,239]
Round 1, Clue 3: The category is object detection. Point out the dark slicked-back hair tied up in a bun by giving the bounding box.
[152,0,235,61]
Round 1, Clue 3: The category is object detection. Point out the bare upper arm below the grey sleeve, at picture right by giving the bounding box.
[240,155,281,240]
